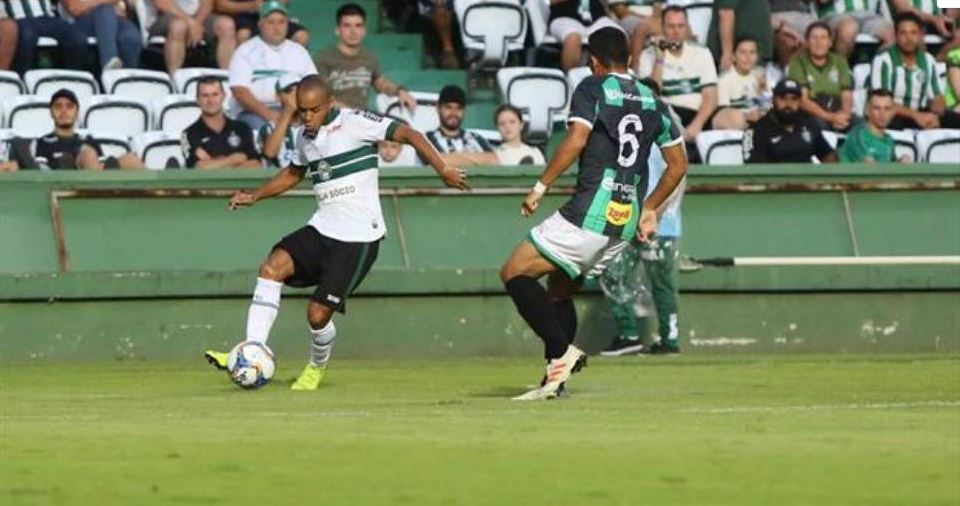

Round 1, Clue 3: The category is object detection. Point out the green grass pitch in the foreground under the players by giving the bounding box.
[0,355,960,506]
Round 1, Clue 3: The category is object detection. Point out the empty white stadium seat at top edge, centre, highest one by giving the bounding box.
[454,0,527,68]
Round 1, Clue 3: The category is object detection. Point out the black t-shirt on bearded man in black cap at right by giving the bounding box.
[743,110,834,163]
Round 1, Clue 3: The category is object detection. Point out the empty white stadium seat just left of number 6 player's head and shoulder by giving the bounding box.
[497,67,568,144]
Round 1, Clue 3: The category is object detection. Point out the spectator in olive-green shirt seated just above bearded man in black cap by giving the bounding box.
[787,21,853,132]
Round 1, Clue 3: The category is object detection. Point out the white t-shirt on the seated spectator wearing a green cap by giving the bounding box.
[229,37,317,114]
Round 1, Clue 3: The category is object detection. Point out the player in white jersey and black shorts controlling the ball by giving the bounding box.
[206,75,467,390]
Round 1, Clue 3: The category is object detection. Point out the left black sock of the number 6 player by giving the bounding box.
[506,276,568,360]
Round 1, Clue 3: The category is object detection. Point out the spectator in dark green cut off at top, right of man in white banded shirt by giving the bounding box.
[707,0,773,72]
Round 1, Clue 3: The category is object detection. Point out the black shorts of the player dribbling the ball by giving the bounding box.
[273,225,380,313]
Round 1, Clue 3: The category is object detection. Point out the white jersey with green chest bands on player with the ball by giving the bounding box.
[291,109,400,242]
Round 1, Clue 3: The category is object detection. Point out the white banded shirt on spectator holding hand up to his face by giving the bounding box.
[639,42,717,111]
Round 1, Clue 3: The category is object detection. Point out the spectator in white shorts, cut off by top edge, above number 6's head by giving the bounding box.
[549,0,619,72]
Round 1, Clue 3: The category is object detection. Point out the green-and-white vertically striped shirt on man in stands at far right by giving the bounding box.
[870,46,943,110]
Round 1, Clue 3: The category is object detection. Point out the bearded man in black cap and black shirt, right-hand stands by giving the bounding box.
[743,79,837,163]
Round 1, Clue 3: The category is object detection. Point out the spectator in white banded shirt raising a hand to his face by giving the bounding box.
[639,5,717,146]
